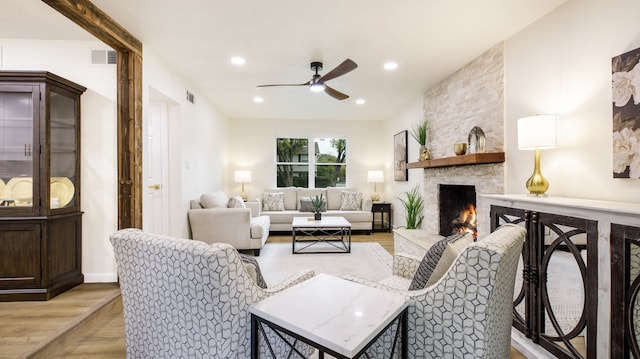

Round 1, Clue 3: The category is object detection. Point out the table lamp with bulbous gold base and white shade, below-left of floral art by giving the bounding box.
[518,115,558,197]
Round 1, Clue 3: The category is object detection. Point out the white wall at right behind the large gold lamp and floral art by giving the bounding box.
[505,0,640,202]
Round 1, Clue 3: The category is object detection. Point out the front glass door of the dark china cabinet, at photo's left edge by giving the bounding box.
[0,86,37,207]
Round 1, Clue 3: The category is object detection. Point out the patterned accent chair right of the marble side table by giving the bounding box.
[346,224,526,359]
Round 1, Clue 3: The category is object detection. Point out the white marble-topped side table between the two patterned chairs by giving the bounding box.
[249,274,408,359]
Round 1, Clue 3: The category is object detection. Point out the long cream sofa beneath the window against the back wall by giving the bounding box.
[258,187,373,234]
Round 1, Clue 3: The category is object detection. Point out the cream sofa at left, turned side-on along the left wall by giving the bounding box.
[189,191,270,255]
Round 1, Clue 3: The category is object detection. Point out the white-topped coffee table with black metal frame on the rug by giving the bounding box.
[291,216,351,254]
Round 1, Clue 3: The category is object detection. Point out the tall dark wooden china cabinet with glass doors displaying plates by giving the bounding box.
[0,71,86,301]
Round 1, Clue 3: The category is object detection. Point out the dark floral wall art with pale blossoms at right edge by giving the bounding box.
[611,49,640,178]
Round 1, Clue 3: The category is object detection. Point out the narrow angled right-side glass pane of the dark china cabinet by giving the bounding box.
[49,91,78,209]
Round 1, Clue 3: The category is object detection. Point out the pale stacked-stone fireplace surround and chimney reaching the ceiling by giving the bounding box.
[412,43,505,236]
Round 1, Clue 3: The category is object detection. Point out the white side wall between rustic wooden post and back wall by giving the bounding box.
[143,46,229,238]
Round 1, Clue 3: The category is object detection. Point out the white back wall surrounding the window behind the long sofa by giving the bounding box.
[225,119,382,199]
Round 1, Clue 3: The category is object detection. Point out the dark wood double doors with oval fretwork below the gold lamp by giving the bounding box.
[491,205,599,358]
